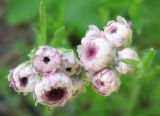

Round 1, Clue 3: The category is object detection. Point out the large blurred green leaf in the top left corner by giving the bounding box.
[6,0,39,25]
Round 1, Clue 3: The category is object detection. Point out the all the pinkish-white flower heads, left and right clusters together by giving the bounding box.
[8,16,139,107]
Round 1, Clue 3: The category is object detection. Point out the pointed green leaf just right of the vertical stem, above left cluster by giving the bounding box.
[50,26,70,48]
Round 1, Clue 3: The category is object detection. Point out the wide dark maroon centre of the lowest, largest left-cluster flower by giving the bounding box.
[45,88,66,102]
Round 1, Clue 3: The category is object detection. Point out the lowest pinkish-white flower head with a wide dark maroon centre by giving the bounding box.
[33,73,72,107]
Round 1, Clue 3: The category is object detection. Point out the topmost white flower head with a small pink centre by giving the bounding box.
[104,16,132,48]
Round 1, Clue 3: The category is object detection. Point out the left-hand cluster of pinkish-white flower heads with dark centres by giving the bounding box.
[8,46,84,107]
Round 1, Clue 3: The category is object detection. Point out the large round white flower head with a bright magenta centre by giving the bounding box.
[78,38,113,71]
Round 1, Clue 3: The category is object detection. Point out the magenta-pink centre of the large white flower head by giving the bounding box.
[86,46,97,60]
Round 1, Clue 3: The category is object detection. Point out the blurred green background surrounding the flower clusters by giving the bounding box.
[0,0,160,116]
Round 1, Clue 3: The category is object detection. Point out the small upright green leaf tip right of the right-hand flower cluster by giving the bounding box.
[142,48,156,68]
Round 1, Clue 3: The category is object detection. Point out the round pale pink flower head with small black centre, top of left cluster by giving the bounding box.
[33,46,61,73]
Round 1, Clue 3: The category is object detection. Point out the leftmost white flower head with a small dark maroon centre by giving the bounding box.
[8,62,40,95]
